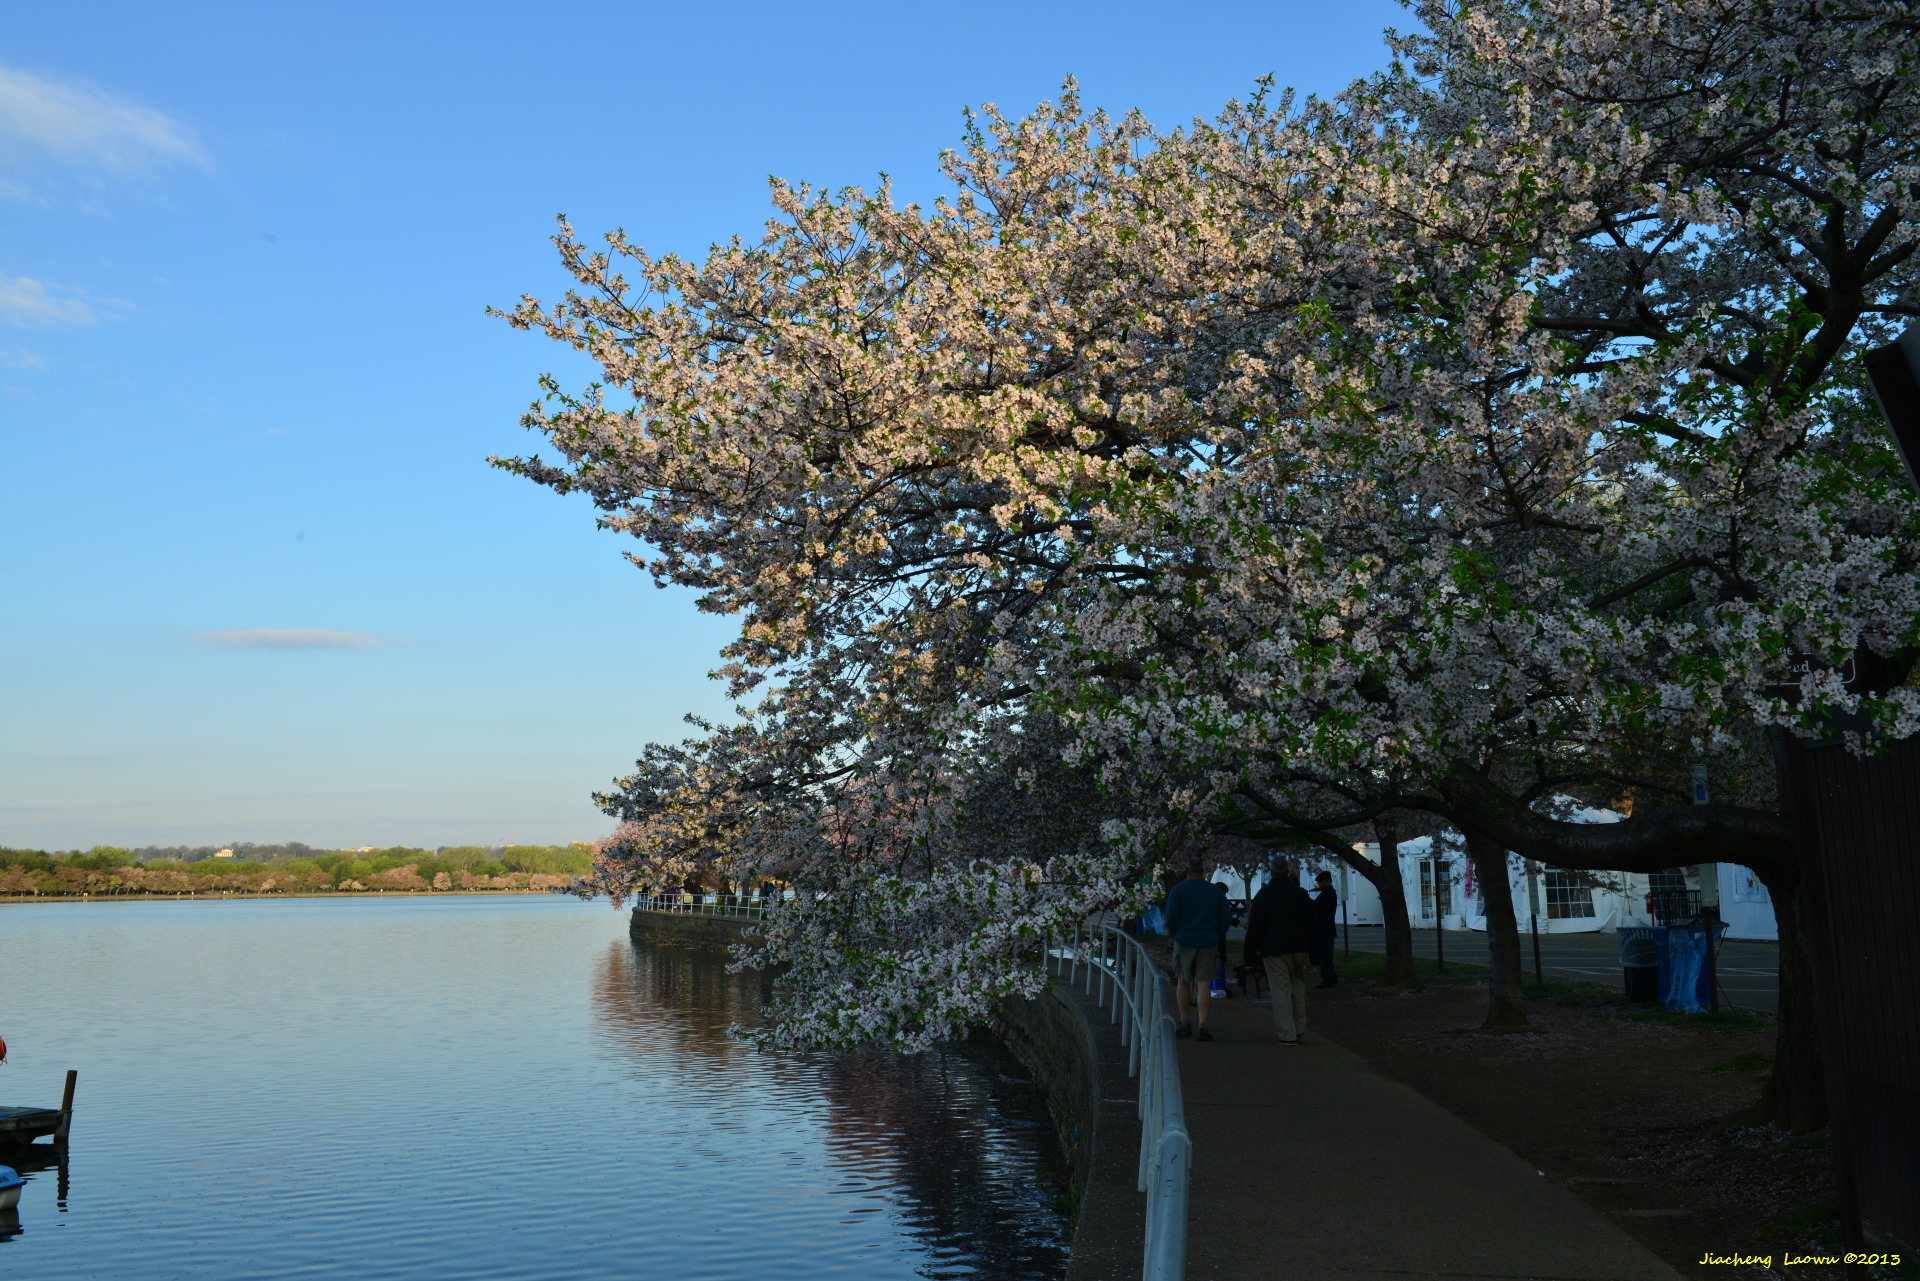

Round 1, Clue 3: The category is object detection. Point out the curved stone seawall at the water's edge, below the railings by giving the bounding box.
[628,908,1146,1281]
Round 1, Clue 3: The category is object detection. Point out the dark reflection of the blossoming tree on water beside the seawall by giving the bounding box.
[593,941,1066,1281]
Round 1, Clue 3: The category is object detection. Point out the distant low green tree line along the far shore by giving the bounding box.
[0,841,593,897]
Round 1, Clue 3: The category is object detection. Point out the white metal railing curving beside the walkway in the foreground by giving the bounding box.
[1046,924,1192,1281]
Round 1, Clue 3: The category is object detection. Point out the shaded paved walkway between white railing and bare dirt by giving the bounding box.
[1181,993,1678,1281]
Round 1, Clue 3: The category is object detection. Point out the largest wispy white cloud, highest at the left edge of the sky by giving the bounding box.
[0,67,211,173]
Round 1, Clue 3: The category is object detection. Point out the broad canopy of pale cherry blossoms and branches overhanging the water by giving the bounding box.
[503,0,1920,1049]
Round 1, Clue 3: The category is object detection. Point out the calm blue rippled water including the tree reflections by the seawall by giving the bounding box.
[0,897,1066,1281]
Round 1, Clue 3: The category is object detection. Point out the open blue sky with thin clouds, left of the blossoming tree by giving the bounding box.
[0,0,1405,849]
